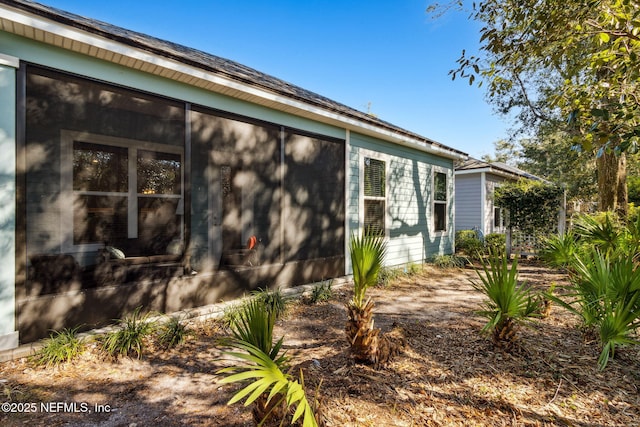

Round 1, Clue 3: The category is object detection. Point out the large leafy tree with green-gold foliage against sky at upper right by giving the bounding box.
[436,0,640,216]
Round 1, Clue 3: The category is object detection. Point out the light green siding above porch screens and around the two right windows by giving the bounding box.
[0,31,454,290]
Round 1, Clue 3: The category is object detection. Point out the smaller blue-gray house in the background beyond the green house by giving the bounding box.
[455,158,541,235]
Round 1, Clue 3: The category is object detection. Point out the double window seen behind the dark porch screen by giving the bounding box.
[62,131,183,254]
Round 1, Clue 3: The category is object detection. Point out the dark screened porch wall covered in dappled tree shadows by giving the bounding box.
[16,67,345,342]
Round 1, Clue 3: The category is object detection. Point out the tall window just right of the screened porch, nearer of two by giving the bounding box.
[364,157,386,236]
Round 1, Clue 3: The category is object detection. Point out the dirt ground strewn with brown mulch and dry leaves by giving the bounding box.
[0,264,640,427]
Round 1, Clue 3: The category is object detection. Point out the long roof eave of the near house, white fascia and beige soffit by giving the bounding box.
[0,3,468,160]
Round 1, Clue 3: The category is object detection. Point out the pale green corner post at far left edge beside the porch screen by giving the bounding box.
[0,56,18,350]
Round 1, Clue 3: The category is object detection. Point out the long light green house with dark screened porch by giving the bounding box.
[0,0,466,350]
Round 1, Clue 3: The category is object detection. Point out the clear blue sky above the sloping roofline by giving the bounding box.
[35,0,509,157]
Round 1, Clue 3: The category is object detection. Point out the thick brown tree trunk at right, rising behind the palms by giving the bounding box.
[596,151,627,219]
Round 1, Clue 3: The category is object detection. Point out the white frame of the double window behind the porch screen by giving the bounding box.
[59,130,184,252]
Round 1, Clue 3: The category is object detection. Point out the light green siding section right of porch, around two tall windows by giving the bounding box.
[347,133,454,266]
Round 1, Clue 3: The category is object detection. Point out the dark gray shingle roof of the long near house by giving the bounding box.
[0,0,466,156]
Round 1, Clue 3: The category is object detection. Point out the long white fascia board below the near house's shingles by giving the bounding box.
[0,6,467,160]
